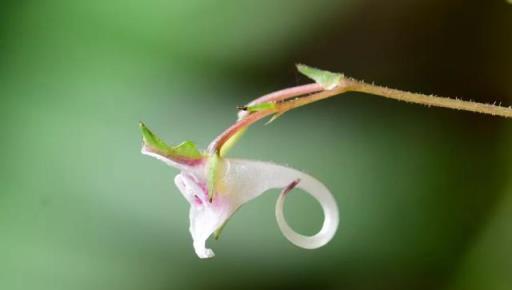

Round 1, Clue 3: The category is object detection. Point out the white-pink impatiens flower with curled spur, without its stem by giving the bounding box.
[140,123,338,258]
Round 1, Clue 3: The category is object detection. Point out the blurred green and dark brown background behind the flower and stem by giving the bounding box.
[0,0,512,290]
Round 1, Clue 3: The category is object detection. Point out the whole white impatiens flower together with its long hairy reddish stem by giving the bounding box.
[141,65,512,258]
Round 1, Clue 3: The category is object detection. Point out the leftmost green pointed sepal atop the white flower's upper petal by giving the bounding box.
[139,122,203,159]
